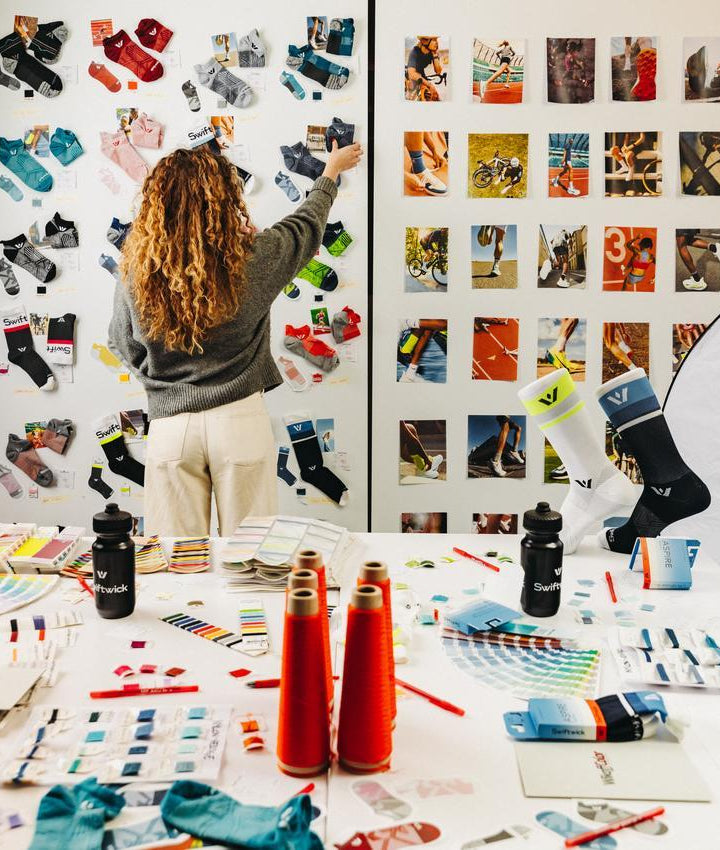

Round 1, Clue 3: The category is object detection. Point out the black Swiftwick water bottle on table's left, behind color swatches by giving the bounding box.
[92,502,135,620]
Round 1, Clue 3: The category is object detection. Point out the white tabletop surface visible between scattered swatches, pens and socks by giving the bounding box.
[0,534,720,850]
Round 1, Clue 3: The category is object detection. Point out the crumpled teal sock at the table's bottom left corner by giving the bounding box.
[28,776,125,850]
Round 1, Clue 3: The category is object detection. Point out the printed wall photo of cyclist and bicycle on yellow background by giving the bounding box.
[468,133,528,198]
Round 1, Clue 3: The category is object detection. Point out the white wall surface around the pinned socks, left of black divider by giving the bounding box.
[0,0,368,529]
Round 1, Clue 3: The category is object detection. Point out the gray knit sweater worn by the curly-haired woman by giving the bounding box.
[108,177,337,419]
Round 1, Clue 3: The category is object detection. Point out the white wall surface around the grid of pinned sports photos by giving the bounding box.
[372,0,720,532]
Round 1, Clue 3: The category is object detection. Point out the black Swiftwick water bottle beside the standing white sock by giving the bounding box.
[520,502,563,617]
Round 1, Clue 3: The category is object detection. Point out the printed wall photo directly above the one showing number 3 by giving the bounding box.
[605,131,663,198]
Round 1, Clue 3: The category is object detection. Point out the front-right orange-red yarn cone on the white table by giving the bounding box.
[337,584,392,773]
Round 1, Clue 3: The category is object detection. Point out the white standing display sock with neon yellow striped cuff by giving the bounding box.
[518,369,636,554]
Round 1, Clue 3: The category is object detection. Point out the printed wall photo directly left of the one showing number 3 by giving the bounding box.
[538,224,587,289]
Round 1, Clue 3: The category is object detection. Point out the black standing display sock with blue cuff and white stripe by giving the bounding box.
[597,369,710,554]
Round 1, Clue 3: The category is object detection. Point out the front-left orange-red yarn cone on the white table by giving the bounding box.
[277,587,330,776]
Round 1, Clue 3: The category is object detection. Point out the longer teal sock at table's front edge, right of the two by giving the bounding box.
[163,780,322,850]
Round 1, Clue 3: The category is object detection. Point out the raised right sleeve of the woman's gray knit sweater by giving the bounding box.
[251,177,337,300]
